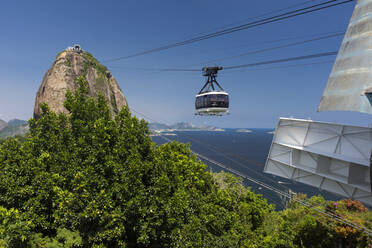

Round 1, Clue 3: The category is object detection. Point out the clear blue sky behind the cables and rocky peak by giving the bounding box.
[0,0,372,128]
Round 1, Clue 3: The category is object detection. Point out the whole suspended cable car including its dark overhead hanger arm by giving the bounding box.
[195,66,229,116]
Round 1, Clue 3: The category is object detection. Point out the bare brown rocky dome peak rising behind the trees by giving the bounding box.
[34,46,128,118]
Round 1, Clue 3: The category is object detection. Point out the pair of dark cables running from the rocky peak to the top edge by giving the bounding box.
[104,0,354,62]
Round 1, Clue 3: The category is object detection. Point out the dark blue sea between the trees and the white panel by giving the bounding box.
[152,129,341,210]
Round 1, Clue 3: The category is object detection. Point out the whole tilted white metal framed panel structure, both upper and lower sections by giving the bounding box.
[264,118,372,206]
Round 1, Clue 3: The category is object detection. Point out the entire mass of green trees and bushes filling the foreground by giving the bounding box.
[0,77,371,248]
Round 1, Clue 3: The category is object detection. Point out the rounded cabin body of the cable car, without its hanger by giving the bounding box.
[195,91,229,115]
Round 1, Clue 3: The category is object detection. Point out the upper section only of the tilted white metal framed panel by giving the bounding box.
[274,118,372,166]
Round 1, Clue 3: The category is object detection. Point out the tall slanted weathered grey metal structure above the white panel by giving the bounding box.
[318,0,372,114]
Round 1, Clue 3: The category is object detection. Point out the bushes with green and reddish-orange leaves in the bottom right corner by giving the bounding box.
[260,194,372,248]
